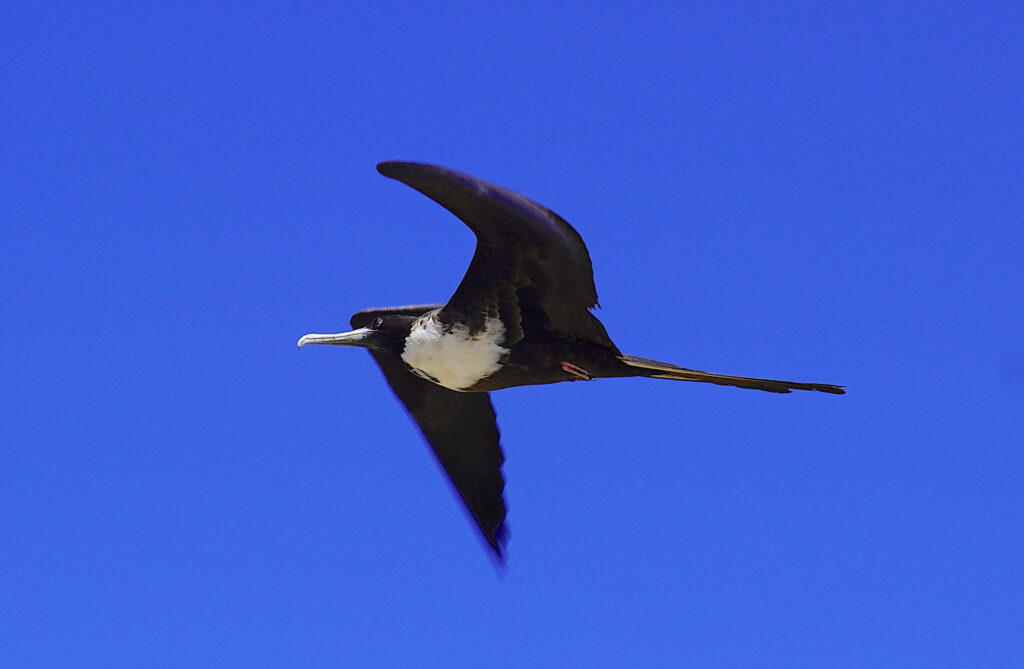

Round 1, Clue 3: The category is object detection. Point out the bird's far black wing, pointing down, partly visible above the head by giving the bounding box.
[352,304,508,561]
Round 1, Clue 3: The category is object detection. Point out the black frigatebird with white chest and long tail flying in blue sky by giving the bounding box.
[298,162,846,562]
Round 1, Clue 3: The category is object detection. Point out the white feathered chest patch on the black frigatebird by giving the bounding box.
[401,317,509,390]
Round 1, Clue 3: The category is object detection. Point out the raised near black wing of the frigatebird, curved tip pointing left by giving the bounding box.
[377,162,618,353]
